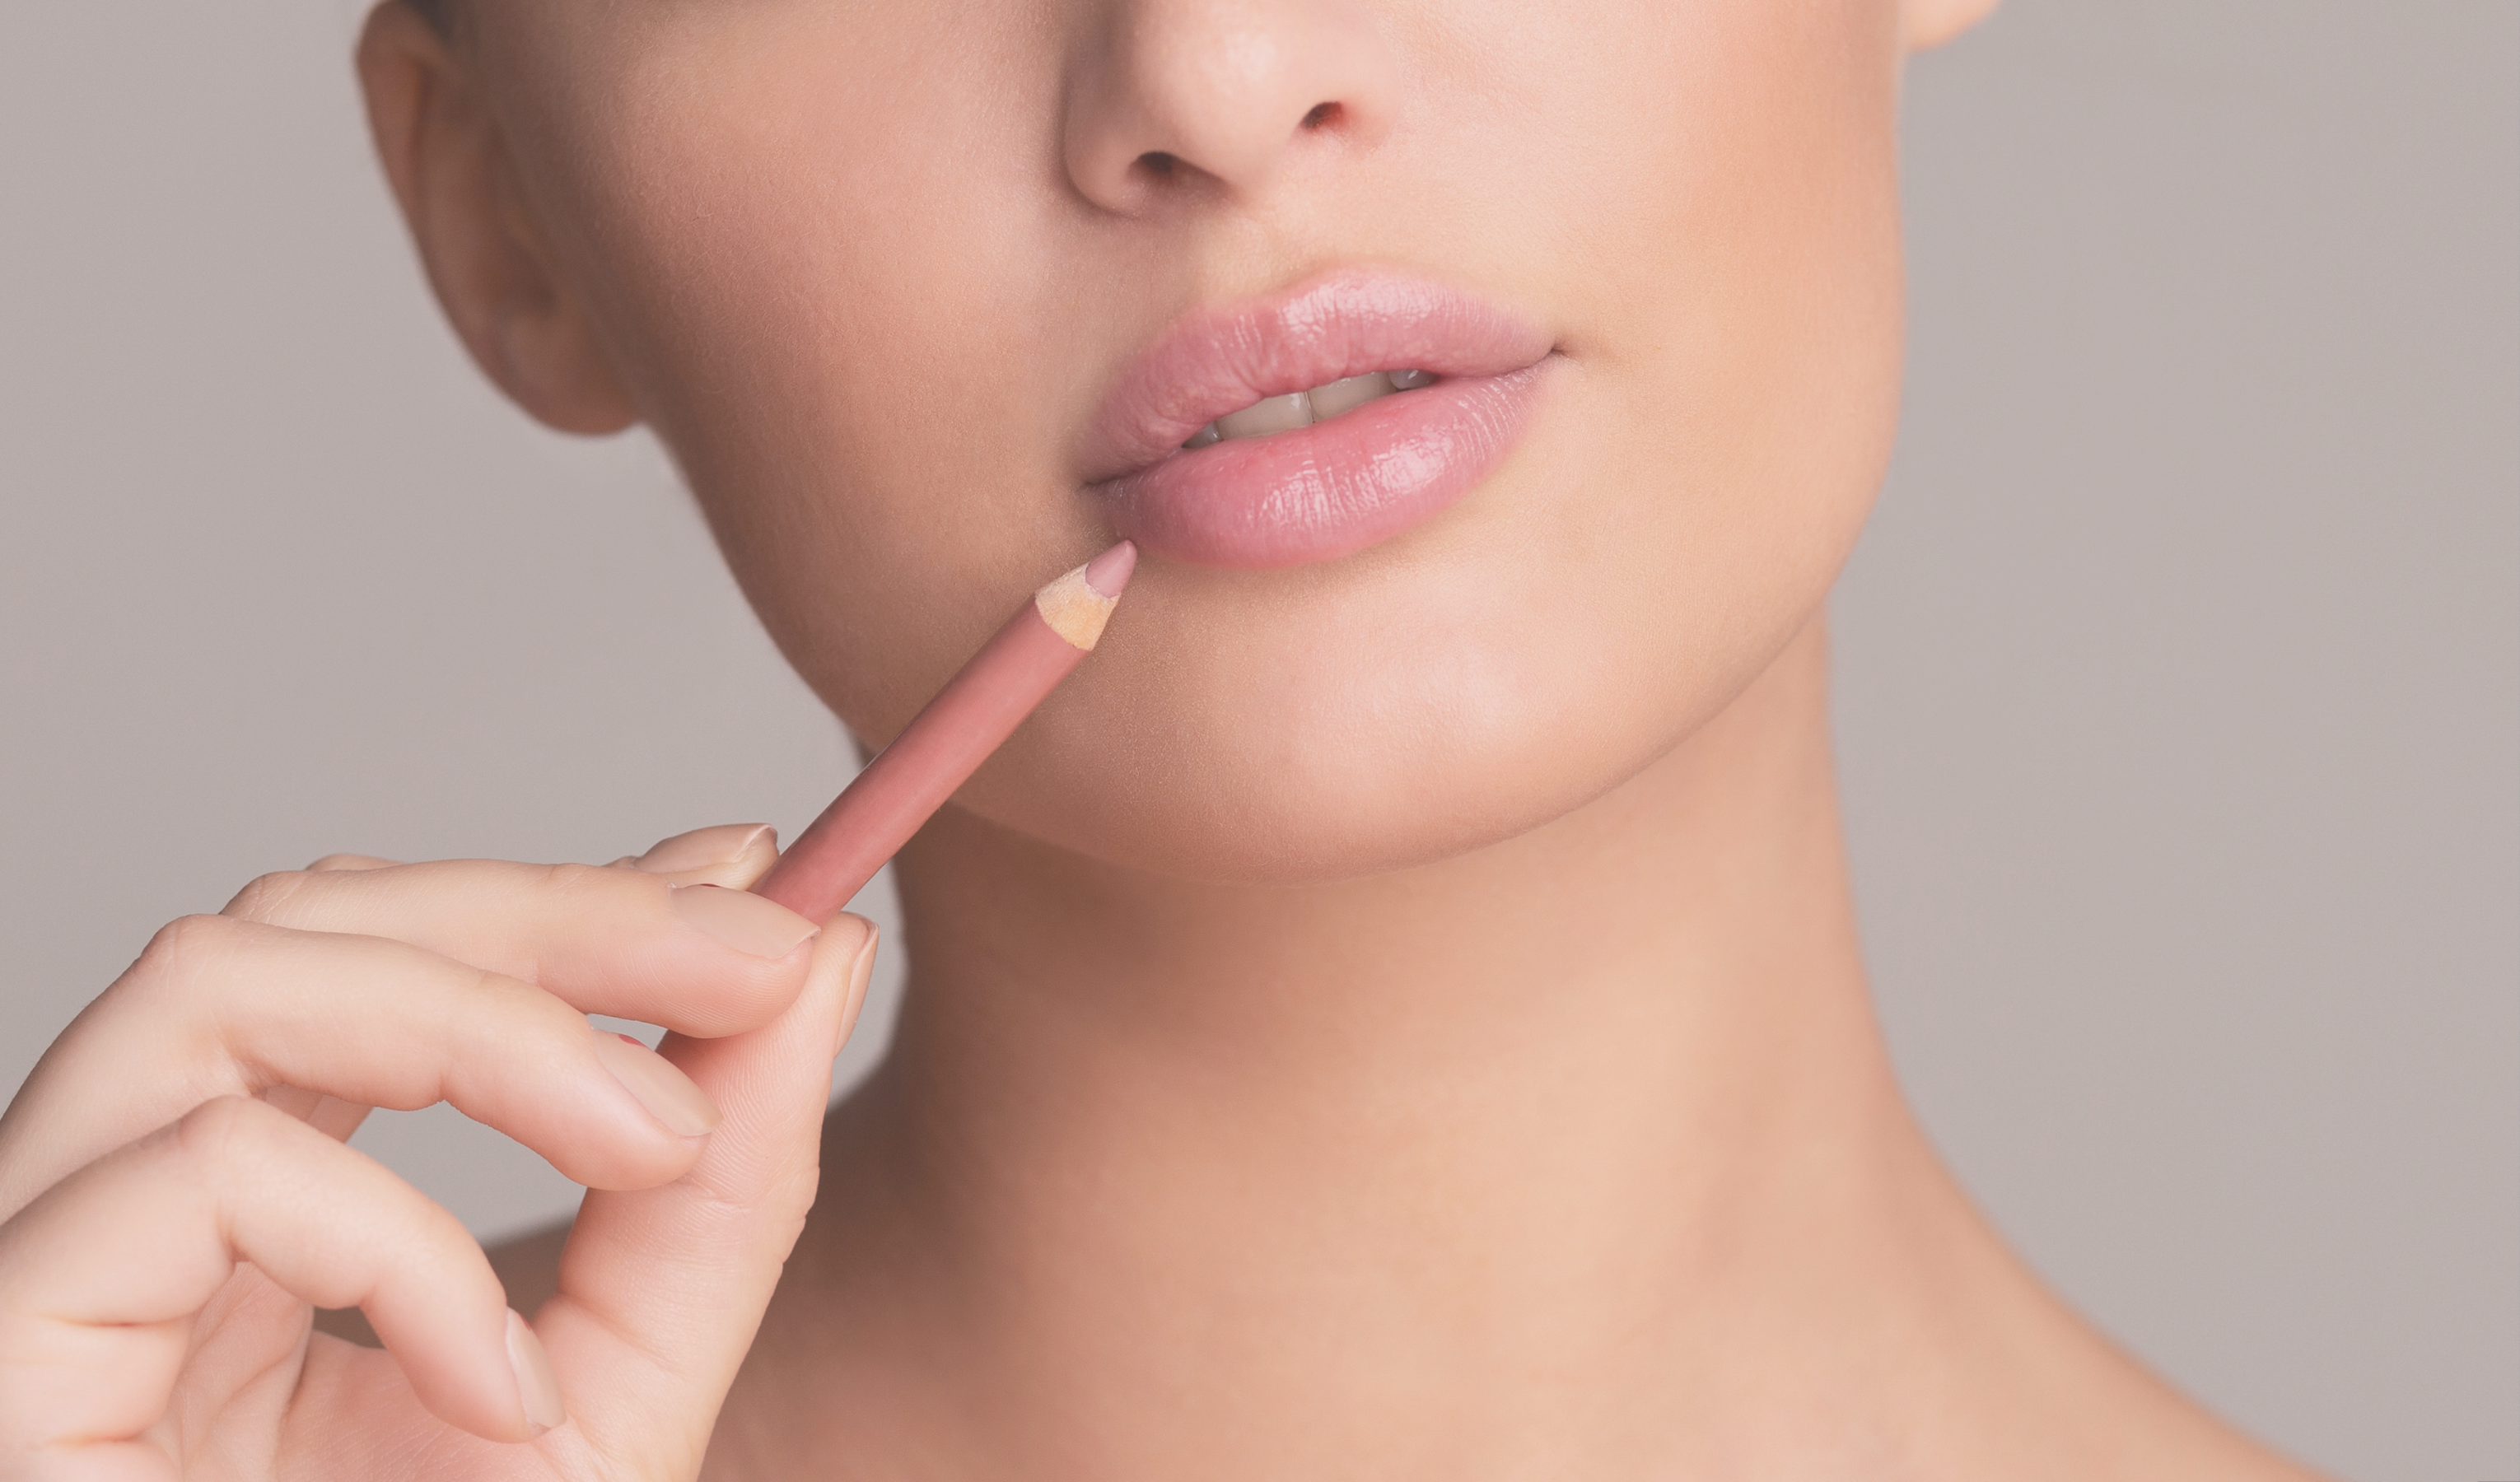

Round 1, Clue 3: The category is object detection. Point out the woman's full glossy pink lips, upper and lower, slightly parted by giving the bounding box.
[1084,270,1550,567]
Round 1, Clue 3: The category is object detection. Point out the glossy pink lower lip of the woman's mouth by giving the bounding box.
[1094,361,1547,567]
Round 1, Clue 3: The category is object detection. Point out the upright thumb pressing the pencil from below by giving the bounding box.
[539,915,877,1477]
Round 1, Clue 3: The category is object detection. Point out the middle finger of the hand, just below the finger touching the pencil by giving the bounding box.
[0,915,718,1212]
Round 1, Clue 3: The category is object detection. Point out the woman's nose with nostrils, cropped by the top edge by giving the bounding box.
[1061,0,1398,214]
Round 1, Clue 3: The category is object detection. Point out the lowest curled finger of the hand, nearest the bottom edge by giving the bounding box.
[0,1099,557,1475]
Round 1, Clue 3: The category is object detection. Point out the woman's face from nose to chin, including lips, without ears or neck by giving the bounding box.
[469,0,1900,879]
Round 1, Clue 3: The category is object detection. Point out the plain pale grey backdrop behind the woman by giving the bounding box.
[0,0,2520,1482]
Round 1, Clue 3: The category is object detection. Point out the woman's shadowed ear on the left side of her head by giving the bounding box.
[358,0,637,434]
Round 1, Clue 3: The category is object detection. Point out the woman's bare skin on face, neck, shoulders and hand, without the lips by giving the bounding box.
[0,0,2301,1482]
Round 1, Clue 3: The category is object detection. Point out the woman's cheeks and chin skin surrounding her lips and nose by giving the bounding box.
[501,0,1897,877]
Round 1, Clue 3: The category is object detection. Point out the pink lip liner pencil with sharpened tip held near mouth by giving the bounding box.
[754,539,1136,920]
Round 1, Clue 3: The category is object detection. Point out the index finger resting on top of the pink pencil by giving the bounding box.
[219,860,816,1036]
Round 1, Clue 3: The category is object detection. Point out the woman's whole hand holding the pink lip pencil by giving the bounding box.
[0,827,875,1482]
